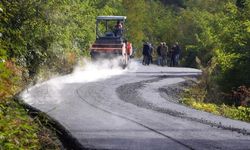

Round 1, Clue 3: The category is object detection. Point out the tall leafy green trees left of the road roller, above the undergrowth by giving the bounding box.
[0,0,121,77]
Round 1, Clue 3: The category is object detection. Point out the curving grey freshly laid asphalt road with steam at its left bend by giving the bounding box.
[22,61,250,150]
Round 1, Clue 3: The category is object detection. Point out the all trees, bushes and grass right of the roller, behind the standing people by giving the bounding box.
[123,0,250,121]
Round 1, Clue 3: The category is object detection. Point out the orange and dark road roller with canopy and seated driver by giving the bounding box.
[90,16,132,68]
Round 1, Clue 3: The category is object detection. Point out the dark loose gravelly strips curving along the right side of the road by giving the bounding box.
[116,77,250,135]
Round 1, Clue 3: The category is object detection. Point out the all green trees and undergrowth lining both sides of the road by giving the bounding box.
[0,0,250,149]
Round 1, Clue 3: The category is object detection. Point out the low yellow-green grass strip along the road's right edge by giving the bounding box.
[181,88,250,122]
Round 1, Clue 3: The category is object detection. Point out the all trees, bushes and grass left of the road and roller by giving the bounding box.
[0,0,120,150]
